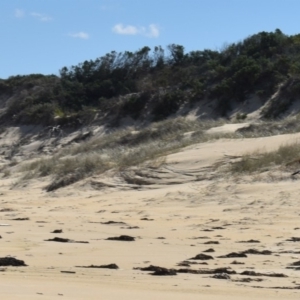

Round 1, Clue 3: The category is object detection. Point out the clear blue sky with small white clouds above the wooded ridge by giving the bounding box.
[0,0,300,79]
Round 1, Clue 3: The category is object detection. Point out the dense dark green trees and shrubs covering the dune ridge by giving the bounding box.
[0,29,300,125]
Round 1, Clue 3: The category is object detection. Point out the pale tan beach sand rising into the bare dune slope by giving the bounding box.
[0,129,300,300]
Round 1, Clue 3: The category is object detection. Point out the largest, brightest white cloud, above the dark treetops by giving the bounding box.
[112,23,159,38]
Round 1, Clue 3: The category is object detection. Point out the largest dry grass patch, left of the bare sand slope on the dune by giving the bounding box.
[20,117,222,190]
